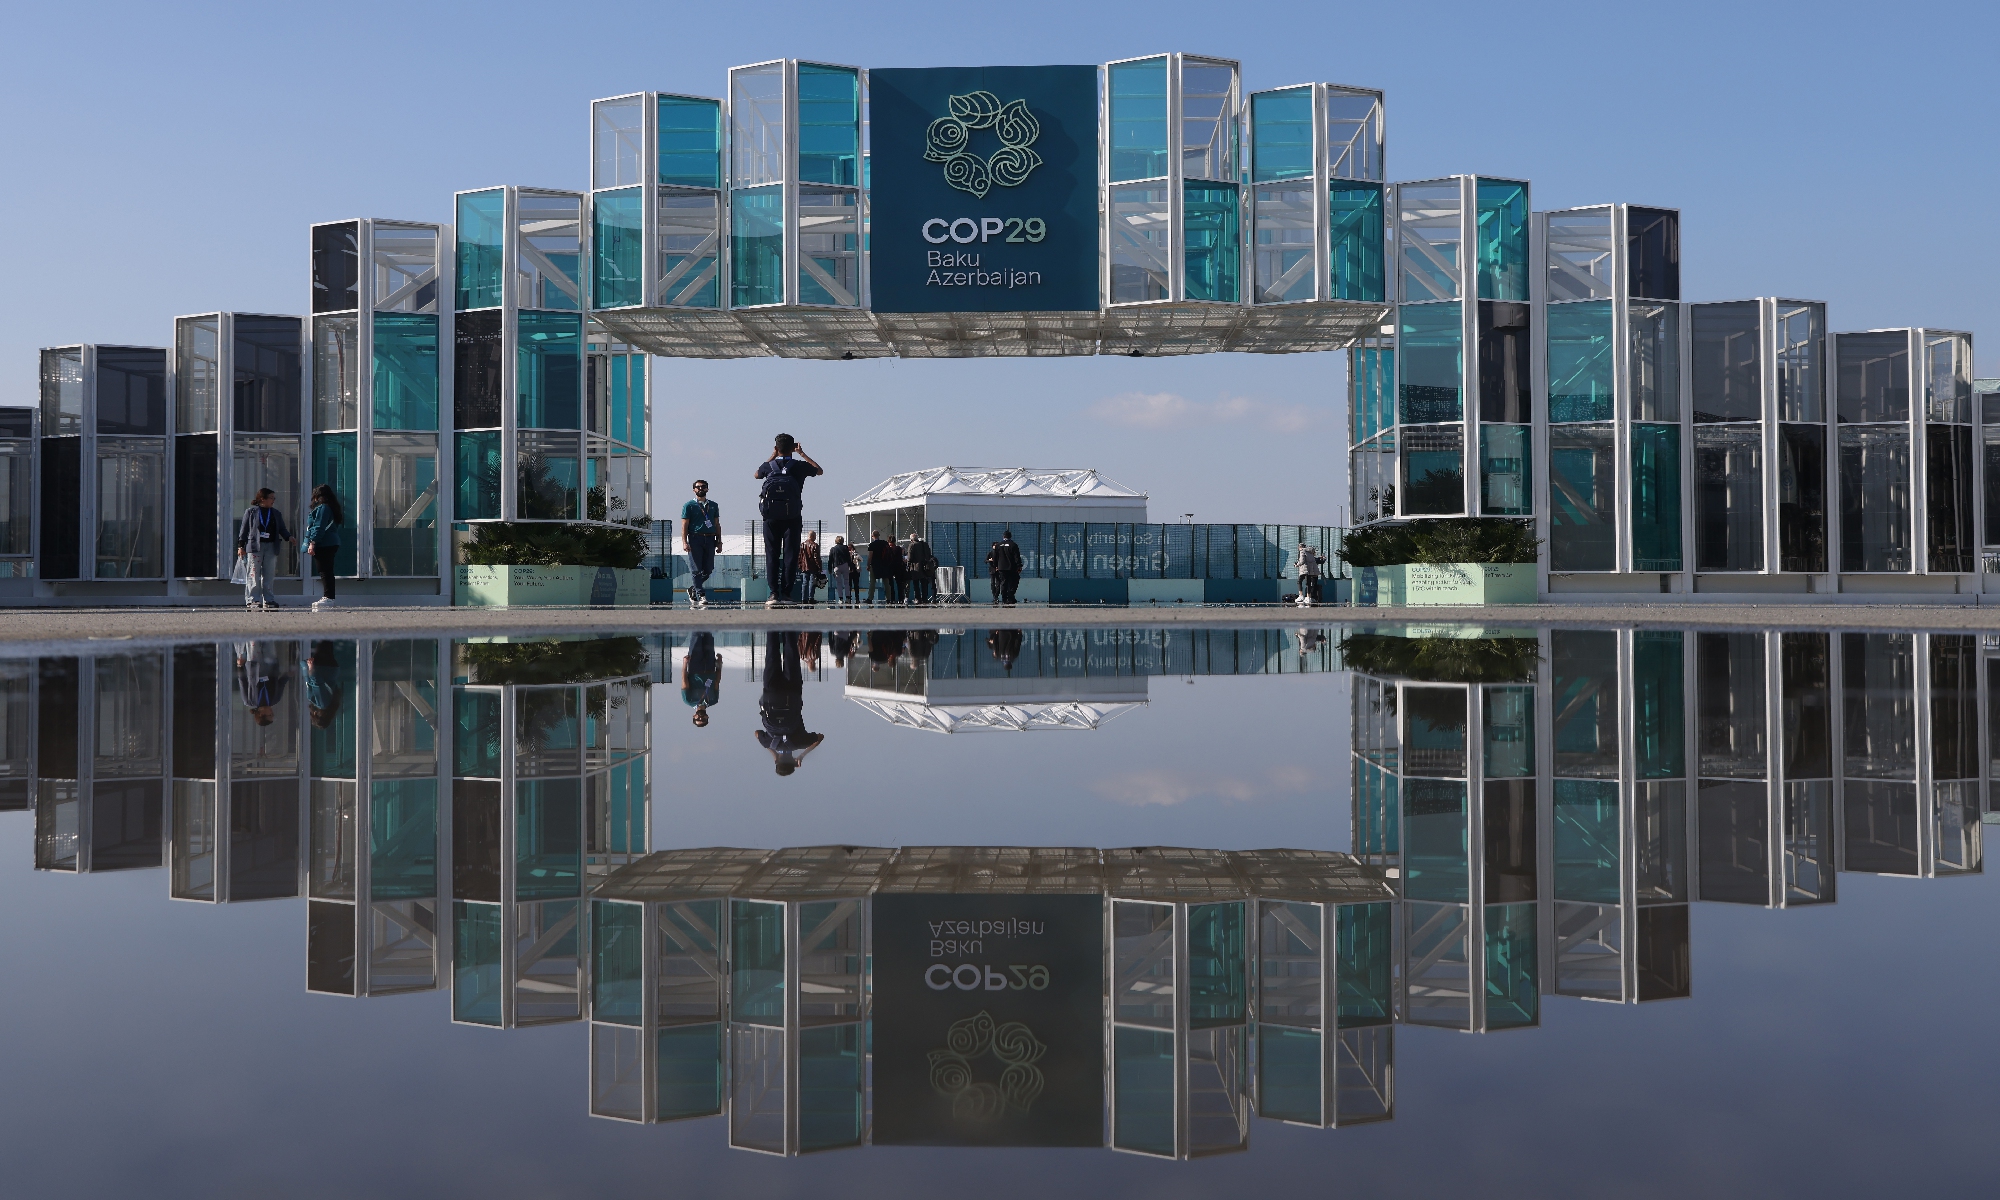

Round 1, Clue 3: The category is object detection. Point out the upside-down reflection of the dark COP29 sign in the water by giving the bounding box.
[874,894,1104,1146]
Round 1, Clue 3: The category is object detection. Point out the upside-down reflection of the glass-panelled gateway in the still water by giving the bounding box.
[0,628,2000,1158]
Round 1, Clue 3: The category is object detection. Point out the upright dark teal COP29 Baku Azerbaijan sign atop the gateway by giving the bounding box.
[868,66,1098,312]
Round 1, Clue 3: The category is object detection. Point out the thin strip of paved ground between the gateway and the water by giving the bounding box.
[0,602,2000,644]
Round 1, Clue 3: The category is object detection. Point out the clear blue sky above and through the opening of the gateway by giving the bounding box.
[0,0,2000,524]
